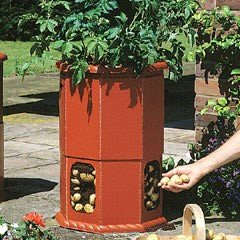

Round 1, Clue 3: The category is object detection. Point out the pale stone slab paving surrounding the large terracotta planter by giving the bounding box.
[0,74,240,240]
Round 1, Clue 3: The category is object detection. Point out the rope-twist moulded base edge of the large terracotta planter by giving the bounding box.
[56,212,167,233]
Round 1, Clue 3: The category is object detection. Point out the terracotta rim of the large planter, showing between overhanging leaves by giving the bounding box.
[56,61,168,75]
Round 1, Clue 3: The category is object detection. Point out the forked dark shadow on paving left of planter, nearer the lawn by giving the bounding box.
[3,92,59,116]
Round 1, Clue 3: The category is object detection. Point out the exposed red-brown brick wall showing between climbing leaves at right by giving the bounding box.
[195,0,240,141]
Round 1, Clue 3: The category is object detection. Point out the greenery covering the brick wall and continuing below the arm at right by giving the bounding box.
[190,6,240,217]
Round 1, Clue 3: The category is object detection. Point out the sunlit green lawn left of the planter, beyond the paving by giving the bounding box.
[0,41,60,76]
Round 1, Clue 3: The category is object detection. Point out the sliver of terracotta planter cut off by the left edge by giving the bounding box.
[0,53,7,201]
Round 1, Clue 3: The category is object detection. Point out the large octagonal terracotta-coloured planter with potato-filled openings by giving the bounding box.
[56,63,167,232]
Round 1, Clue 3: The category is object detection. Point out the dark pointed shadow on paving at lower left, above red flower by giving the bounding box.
[2,178,57,201]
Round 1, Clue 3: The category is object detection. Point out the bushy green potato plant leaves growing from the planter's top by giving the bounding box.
[21,0,198,84]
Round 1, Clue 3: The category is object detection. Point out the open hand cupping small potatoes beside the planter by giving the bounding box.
[162,163,205,193]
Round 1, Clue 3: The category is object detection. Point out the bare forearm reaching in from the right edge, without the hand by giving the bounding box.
[197,131,240,175]
